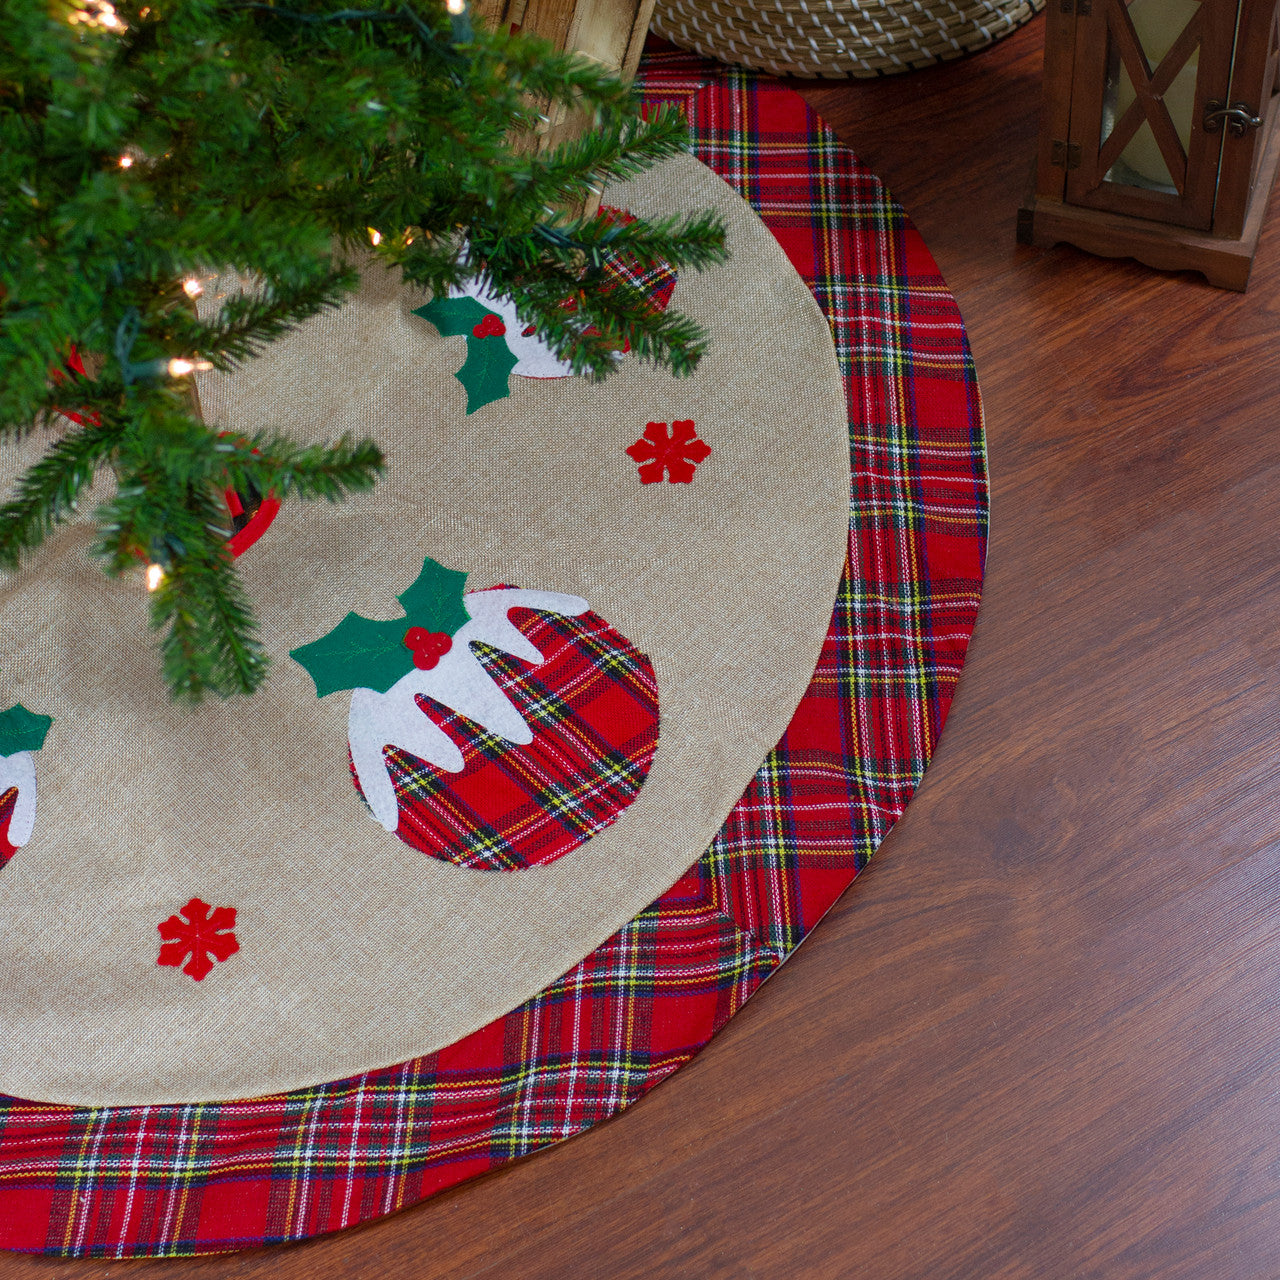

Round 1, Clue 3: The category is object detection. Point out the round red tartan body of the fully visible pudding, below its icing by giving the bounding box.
[376,609,658,870]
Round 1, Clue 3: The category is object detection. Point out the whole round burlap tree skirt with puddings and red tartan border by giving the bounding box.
[0,55,986,1256]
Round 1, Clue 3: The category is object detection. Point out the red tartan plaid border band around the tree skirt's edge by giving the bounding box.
[0,54,987,1257]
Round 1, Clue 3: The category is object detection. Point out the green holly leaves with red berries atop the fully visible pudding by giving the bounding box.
[289,557,470,698]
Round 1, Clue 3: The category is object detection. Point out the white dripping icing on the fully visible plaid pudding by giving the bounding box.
[350,588,589,831]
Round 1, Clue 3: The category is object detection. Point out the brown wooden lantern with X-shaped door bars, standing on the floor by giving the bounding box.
[1018,0,1280,289]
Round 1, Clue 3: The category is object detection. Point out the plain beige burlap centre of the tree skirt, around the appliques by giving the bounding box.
[0,157,849,1105]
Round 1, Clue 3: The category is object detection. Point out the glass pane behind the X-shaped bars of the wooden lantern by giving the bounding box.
[1101,0,1199,196]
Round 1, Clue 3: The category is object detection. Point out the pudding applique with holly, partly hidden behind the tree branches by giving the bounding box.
[413,206,677,413]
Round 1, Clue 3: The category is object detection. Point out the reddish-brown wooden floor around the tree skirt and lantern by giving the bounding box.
[15,22,1280,1280]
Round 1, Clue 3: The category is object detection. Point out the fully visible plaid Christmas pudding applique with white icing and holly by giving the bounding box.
[292,559,658,870]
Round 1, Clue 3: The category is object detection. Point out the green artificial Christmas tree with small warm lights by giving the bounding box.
[0,0,723,701]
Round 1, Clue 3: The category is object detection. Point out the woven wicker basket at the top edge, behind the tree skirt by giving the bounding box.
[653,0,1044,77]
